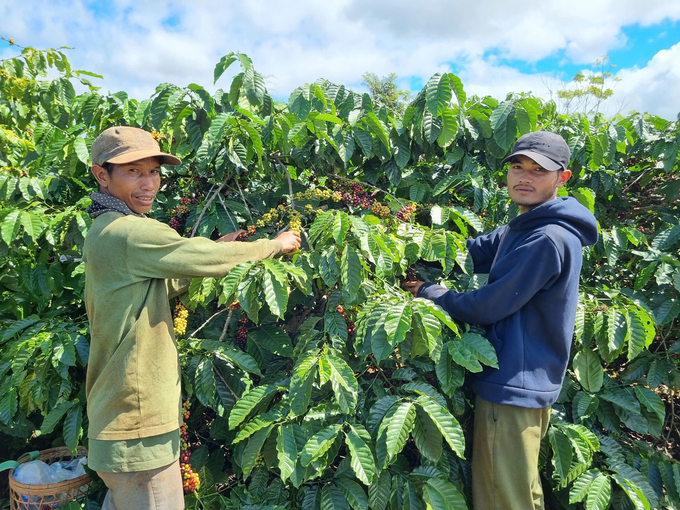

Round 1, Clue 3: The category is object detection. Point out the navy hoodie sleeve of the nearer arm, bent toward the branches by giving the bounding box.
[418,235,562,324]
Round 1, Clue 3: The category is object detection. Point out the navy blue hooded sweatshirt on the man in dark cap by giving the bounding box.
[418,197,597,408]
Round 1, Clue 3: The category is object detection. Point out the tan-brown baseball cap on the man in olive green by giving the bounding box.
[92,126,182,166]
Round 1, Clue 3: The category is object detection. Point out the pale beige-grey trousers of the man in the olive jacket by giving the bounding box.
[97,460,184,510]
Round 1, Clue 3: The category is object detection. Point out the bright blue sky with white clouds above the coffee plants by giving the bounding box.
[0,0,680,120]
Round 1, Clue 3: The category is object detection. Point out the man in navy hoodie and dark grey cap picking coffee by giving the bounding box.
[404,131,597,510]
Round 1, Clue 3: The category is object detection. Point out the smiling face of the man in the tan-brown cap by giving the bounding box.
[92,158,161,214]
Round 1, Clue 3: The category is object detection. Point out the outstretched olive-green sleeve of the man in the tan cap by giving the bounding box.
[125,219,283,280]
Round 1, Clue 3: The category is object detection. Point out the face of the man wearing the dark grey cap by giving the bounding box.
[508,155,571,214]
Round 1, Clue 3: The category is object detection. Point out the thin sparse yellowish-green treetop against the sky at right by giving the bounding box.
[557,55,621,114]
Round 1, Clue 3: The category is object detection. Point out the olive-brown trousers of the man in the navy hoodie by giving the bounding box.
[472,396,550,510]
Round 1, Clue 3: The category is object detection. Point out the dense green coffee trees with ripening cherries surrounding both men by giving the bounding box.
[0,44,680,510]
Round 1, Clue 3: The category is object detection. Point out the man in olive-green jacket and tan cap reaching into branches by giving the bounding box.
[83,127,300,510]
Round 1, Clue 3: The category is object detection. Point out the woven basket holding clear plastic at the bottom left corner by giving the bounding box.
[9,446,92,510]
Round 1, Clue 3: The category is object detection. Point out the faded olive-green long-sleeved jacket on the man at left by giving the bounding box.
[83,212,282,440]
